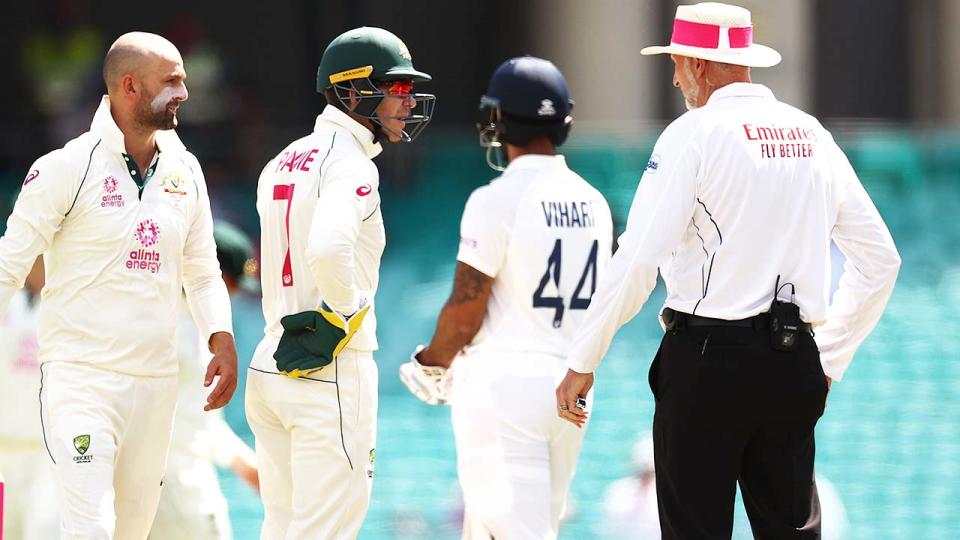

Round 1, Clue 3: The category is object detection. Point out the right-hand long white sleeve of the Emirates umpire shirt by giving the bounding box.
[815,144,900,380]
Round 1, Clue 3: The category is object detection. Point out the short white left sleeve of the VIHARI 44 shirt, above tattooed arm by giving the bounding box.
[457,186,510,278]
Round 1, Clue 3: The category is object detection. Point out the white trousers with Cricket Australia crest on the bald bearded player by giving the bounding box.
[40,362,177,540]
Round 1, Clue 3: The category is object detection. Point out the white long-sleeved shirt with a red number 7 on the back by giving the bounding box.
[251,105,386,372]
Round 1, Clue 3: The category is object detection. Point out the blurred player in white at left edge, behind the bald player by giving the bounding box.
[0,258,60,540]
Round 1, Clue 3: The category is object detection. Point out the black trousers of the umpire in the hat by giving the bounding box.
[649,326,827,540]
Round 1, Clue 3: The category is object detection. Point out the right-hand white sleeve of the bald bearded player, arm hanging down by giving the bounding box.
[182,157,233,343]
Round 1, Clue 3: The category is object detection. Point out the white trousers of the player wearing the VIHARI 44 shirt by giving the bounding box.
[451,353,593,540]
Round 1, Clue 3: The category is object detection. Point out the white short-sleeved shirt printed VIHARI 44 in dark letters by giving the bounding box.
[457,154,613,356]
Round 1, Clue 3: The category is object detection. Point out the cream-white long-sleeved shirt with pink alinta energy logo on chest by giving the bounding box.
[0,96,233,376]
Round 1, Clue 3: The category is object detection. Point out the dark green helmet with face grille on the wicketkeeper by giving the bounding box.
[317,26,437,142]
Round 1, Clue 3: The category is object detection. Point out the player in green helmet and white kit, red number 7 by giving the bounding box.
[246,27,434,540]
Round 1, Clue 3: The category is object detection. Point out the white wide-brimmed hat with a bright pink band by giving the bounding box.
[640,2,781,67]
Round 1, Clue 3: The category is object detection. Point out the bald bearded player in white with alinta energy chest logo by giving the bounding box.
[0,33,236,540]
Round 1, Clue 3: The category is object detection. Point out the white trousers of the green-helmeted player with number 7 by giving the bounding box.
[246,346,378,540]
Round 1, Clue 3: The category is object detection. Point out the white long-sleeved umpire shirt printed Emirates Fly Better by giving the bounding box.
[569,83,900,380]
